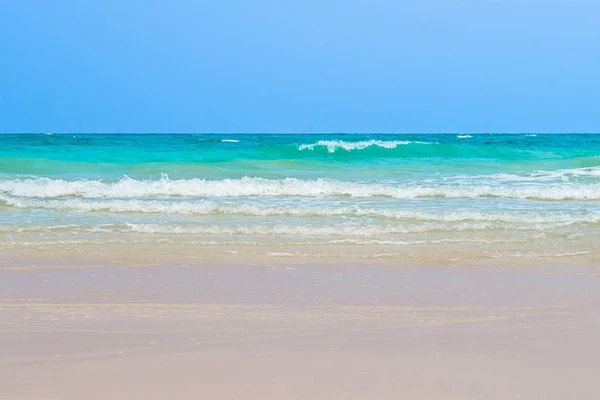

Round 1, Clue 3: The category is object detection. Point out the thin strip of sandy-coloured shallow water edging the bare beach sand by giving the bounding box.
[0,241,600,269]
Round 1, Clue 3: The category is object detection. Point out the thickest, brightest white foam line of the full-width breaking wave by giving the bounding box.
[0,175,600,200]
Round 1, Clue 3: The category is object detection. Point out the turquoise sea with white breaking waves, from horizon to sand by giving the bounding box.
[0,134,600,261]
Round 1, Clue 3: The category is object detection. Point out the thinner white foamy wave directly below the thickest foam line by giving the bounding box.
[3,198,600,225]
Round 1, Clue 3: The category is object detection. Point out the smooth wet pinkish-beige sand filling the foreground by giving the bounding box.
[0,257,600,400]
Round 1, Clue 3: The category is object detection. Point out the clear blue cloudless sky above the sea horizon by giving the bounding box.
[0,0,600,133]
